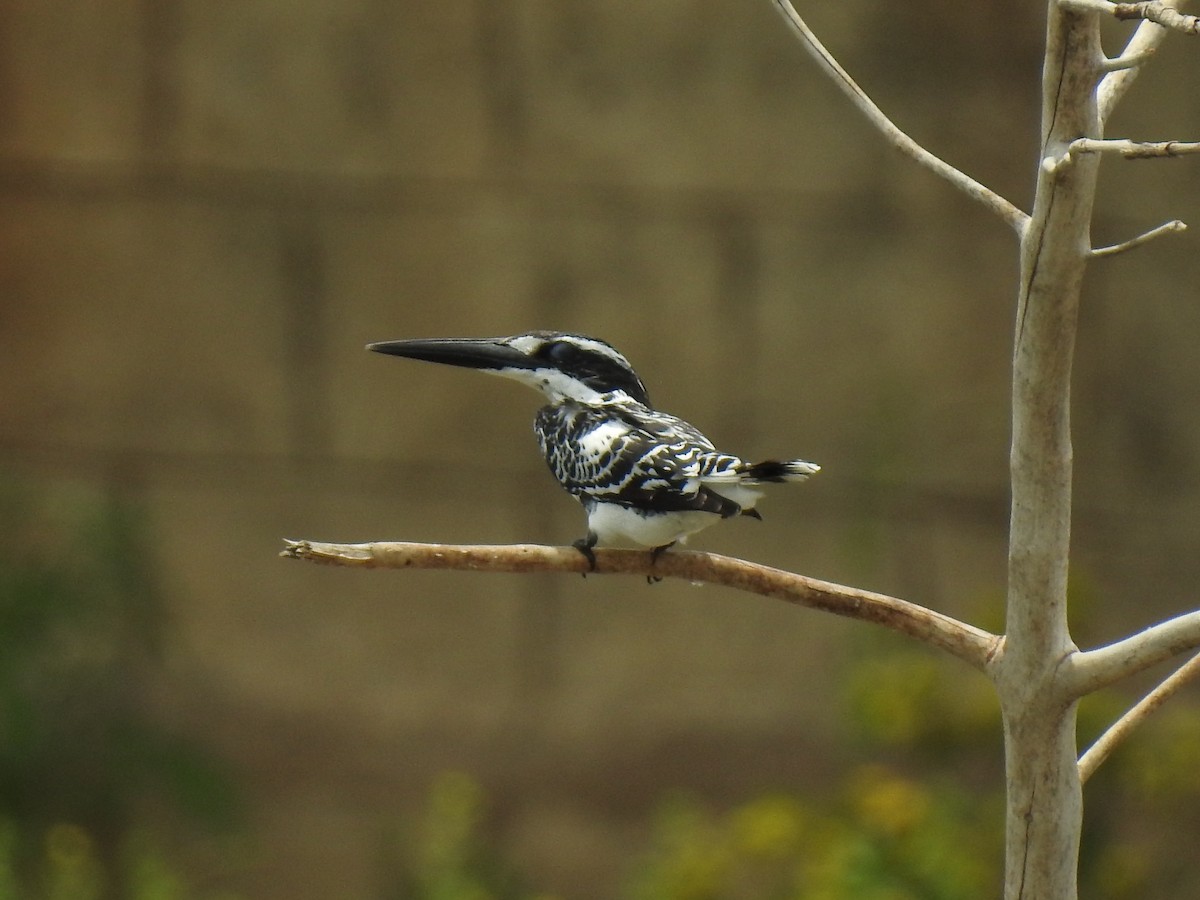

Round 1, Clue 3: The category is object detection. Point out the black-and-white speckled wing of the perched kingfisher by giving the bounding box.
[534,403,743,517]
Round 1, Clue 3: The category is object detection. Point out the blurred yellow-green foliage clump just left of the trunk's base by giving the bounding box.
[630,635,1003,900]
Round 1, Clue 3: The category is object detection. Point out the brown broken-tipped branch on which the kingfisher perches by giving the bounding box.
[280,540,1000,671]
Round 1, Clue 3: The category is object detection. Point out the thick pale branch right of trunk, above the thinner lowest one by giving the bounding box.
[1060,611,1200,697]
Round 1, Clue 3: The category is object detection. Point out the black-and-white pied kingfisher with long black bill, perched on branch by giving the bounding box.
[367,331,821,569]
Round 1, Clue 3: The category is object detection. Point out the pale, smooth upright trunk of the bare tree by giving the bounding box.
[994,2,1103,900]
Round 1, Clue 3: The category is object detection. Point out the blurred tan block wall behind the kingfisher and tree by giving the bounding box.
[0,0,1200,898]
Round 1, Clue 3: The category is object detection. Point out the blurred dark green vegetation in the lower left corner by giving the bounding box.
[0,479,238,900]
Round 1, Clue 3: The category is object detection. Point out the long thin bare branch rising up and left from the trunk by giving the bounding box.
[772,0,1030,234]
